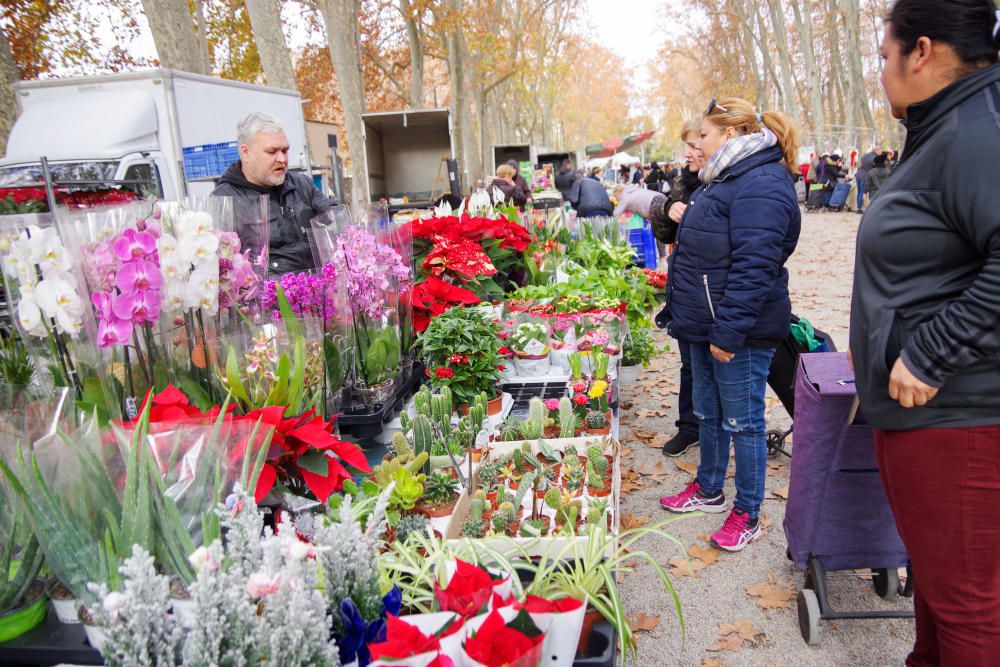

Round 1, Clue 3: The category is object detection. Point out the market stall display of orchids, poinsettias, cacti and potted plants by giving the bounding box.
[0,189,671,666]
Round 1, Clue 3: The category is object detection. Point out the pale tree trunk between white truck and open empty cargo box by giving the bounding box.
[320,0,371,206]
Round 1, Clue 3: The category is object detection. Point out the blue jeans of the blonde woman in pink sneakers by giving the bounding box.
[691,343,774,518]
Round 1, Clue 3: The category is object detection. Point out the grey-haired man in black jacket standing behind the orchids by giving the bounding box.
[212,112,337,275]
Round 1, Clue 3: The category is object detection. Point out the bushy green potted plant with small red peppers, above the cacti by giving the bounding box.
[417,307,502,415]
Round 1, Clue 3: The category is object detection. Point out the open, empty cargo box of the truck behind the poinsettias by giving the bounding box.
[361,109,462,211]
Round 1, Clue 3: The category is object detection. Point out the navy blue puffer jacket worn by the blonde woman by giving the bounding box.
[657,146,802,352]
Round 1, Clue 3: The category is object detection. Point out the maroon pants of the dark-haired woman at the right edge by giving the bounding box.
[875,426,1000,667]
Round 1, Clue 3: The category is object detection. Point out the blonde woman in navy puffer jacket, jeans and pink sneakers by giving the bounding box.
[622,98,801,551]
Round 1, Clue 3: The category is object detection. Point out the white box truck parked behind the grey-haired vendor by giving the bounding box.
[0,69,311,199]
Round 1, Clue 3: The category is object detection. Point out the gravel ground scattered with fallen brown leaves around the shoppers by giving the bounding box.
[622,213,914,666]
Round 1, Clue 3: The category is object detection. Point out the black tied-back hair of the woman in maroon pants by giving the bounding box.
[886,0,1000,68]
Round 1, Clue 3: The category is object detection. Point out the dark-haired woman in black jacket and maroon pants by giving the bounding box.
[850,0,1000,665]
